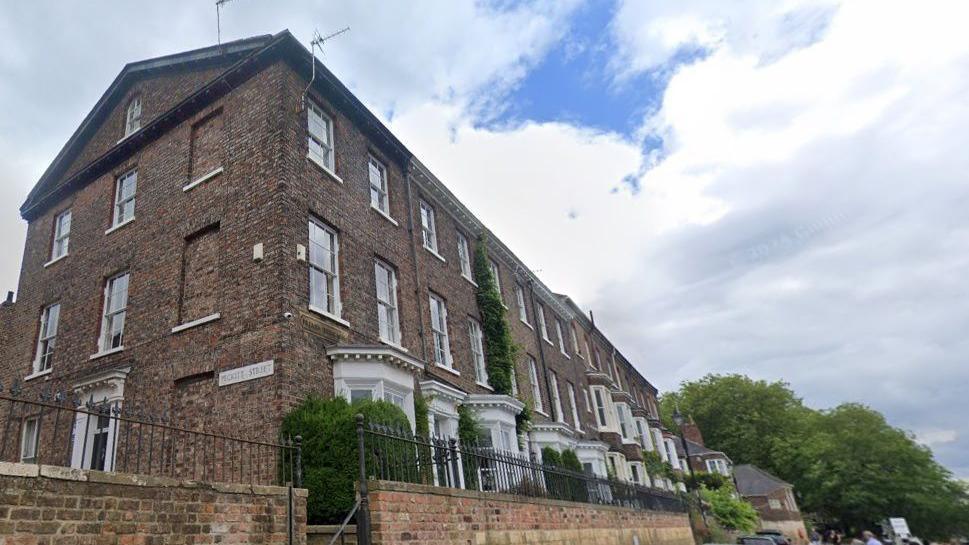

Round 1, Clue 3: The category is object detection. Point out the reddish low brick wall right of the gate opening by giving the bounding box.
[369,481,693,545]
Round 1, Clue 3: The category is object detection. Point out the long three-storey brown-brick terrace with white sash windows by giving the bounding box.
[0,31,680,484]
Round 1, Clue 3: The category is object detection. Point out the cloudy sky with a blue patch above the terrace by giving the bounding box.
[0,0,969,478]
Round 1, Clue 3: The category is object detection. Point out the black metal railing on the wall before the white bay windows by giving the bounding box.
[358,421,686,512]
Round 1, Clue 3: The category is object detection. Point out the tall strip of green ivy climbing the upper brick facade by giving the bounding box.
[474,235,518,395]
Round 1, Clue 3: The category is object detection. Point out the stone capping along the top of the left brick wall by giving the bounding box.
[0,462,309,498]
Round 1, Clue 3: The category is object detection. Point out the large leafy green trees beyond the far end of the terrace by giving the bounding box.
[661,375,969,540]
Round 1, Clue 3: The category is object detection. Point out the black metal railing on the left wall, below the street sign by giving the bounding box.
[0,382,302,487]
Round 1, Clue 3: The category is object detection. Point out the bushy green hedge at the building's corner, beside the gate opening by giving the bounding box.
[282,396,410,524]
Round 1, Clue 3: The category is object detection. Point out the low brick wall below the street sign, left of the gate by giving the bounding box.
[0,463,306,545]
